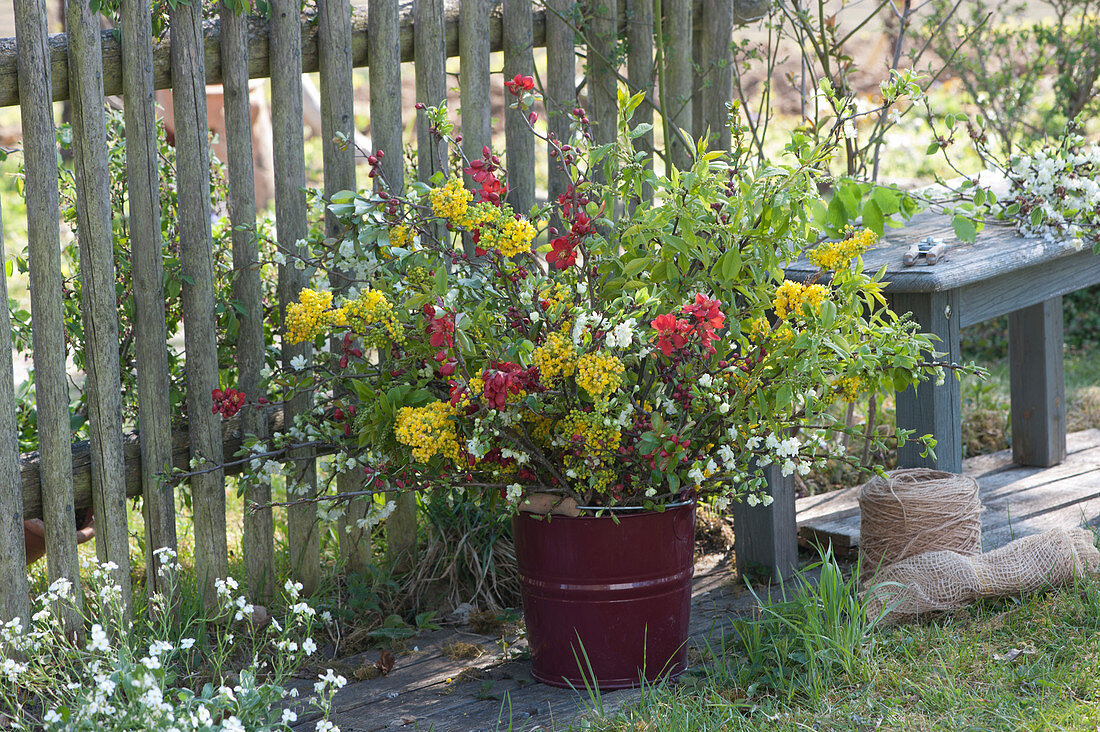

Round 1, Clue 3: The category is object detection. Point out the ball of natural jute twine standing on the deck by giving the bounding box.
[859,468,981,571]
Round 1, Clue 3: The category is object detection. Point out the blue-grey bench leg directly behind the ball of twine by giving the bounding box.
[891,292,963,472]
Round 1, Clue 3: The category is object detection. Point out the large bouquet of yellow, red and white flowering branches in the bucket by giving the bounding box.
[285,84,942,511]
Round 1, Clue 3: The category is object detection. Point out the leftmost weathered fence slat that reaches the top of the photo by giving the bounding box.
[15,0,81,633]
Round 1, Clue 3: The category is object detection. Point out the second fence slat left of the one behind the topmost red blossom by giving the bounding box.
[413,0,447,181]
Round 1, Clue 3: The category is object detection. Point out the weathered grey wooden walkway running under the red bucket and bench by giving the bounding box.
[295,429,1100,732]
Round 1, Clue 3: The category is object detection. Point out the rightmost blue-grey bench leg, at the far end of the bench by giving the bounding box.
[1009,296,1066,468]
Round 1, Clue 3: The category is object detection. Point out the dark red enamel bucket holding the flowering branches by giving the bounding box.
[513,503,695,689]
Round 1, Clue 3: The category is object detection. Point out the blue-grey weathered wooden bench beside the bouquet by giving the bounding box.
[734,214,1100,577]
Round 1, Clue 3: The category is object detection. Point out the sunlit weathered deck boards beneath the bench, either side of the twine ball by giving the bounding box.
[798,429,1100,551]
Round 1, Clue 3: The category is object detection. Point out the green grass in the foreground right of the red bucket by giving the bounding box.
[579,534,1100,732]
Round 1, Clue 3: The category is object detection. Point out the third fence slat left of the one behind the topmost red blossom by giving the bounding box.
[366,0,416,568]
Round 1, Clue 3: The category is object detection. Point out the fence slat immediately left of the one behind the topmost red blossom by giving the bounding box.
[459,0,492,200]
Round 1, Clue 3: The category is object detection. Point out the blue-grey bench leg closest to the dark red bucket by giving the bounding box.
[730,466,799,579]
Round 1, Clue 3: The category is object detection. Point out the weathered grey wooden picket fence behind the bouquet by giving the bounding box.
[0,0,760,627]
